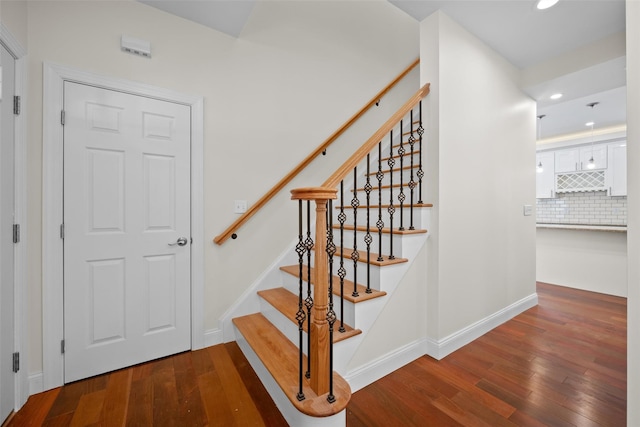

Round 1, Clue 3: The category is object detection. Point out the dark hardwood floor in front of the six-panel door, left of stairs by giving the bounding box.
[7,342,287,427]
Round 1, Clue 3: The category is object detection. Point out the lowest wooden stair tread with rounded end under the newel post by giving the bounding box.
[233,313,351,417]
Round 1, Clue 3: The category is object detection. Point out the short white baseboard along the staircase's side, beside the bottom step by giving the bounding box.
[345,339,427,393]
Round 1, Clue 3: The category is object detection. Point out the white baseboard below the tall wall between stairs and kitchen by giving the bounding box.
[426,293,538,360]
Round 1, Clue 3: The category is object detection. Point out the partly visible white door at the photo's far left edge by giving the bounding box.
[0,44,15,424]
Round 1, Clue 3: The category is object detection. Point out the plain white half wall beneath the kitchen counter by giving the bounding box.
[536,228,627,297]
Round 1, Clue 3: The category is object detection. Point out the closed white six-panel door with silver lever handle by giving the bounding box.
[63,82,191,382]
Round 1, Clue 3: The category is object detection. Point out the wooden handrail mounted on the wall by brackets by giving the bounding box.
[213,58,420,245]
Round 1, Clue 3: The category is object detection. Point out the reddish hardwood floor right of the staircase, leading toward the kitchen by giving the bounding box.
[347,283,627,427]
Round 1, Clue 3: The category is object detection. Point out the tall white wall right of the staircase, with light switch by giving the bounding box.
[420,12,535,348]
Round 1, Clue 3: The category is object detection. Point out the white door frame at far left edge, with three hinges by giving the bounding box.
[0,22,29,410]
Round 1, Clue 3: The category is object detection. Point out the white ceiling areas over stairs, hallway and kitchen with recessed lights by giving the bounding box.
[138,0,626,137]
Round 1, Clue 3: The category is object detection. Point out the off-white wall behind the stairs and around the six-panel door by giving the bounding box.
[28,0,418,372]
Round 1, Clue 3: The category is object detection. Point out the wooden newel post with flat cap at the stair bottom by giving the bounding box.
[291,187,338,396]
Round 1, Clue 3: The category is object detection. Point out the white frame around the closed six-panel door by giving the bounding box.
[42,62,204,390]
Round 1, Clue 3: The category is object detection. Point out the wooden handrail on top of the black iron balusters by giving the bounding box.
[322,83,429,188]
